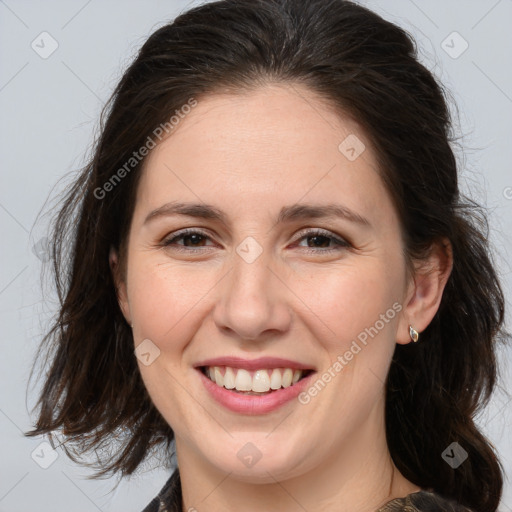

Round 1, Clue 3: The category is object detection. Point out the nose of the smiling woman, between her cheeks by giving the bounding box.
[213,246,292,340]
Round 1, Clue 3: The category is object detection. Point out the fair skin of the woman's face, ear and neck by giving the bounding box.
[111,84,452,512]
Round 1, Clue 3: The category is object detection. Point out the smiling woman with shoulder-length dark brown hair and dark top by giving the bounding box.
[30,0,504,512]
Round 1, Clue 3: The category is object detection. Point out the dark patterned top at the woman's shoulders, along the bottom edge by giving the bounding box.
[142,469,474,512]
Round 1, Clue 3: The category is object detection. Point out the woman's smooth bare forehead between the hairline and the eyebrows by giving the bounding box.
[133,85,391,232]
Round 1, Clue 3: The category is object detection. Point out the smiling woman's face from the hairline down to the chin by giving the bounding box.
[116,85,416,483]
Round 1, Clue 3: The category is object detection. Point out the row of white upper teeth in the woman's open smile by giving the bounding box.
[206,366,304,393]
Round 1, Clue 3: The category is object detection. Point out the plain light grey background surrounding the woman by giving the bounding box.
[0,0,512,512]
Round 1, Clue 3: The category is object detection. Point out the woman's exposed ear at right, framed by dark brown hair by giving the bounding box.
[396,238,453,345]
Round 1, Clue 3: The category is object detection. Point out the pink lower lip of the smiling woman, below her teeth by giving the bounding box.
[196,368,316,416]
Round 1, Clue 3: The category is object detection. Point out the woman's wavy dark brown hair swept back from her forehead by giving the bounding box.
[28,0,505,512]
